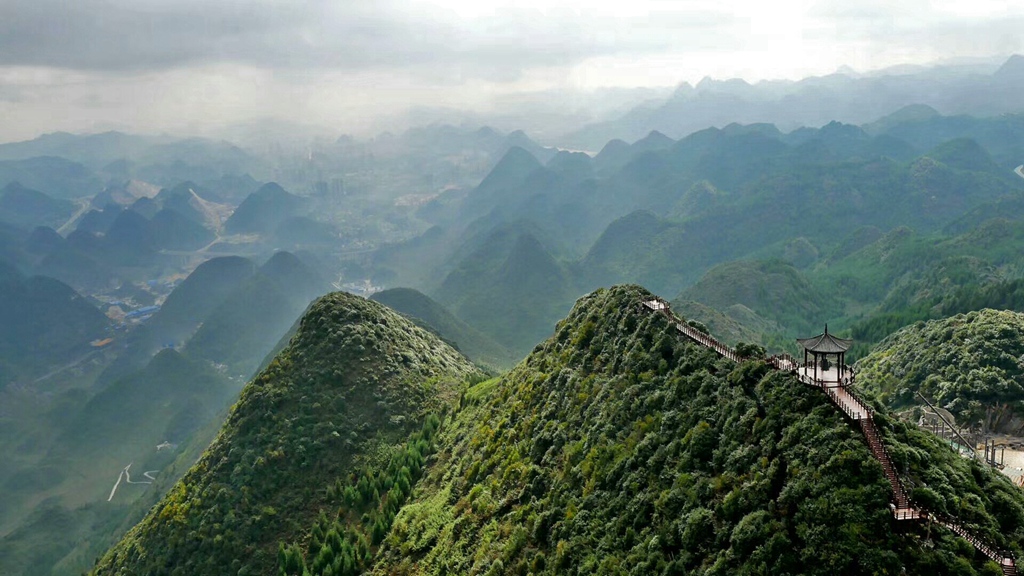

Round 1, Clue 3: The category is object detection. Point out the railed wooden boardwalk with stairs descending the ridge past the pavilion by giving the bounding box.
[643,298,1017,576]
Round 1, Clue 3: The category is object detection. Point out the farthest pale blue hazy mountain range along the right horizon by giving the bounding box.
[560,54,1024,151]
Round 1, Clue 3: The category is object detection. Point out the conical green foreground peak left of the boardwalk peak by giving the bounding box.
[94,293,477,574]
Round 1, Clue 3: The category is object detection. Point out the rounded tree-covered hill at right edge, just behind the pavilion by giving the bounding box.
[856,310,1024,435]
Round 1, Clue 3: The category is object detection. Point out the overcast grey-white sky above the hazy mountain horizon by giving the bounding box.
[0,0,1024,141]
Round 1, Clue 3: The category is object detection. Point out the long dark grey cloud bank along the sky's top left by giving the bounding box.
[0,0,727,81]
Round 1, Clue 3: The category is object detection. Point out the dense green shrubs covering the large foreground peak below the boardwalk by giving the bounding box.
[373,287,1021,575]
